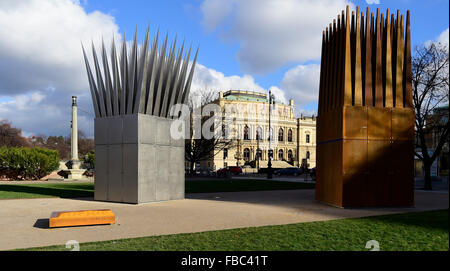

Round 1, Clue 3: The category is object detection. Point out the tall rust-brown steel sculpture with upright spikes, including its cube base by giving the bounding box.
[316,6,414,207]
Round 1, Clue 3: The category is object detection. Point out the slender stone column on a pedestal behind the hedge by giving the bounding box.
[68,96,85,179]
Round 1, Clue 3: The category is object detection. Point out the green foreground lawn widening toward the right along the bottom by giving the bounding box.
[22,209,449,251]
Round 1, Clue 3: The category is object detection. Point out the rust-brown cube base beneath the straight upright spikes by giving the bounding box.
[316,106,414,207]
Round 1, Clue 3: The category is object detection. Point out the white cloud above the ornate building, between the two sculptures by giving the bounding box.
[201,0,353,73]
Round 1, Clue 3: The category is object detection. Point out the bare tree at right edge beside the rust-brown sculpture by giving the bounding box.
[412,43,449,190]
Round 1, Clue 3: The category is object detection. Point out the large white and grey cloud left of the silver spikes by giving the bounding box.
[0,0,120,136]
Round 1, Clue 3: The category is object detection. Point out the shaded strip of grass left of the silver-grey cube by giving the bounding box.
[0,184,94,198]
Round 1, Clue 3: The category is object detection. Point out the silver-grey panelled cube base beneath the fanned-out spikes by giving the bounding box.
[94,114,184,203]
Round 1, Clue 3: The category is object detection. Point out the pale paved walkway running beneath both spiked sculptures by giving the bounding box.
[0,190,449,250]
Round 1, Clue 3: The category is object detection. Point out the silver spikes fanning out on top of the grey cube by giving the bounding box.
[81,28,198,118]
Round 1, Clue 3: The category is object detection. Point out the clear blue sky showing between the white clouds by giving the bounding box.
[83,0,449,89]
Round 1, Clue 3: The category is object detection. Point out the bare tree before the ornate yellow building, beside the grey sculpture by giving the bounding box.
[185,91,233,174]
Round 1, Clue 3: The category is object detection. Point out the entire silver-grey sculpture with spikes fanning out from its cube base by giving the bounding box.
[82,26,198,203]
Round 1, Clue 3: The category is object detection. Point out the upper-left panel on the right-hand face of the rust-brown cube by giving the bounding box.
[343,106,367,139]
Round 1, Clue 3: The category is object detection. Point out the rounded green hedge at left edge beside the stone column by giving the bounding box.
[0,146,59,180]
